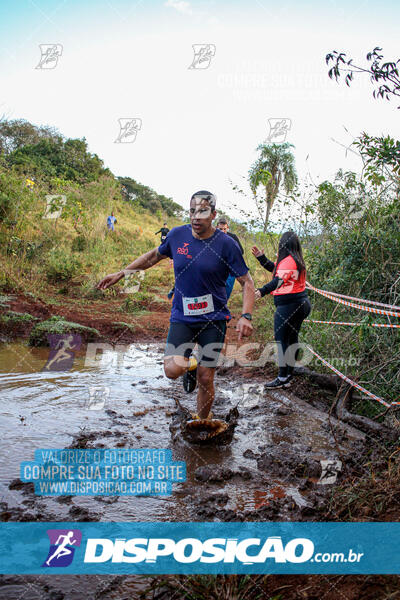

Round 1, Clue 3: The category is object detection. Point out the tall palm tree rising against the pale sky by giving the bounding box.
[248,142,297,233]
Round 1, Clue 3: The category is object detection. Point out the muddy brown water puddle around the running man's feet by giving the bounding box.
[0,343,364,521]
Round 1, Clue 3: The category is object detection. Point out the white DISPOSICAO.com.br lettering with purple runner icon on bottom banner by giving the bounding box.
[41,529,364,573]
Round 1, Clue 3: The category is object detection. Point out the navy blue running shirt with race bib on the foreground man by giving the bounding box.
[158,225,249,323]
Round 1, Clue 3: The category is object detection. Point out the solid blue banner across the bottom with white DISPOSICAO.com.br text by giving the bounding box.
[0,522,400,575]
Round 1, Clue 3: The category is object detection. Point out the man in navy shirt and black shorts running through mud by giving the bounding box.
[97,190,255,419]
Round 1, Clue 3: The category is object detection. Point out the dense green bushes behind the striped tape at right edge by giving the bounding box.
[304,134,400,412]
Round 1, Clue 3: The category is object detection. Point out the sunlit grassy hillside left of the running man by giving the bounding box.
[0,165,182,296]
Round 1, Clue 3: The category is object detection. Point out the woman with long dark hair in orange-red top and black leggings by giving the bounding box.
[251,231,311,388]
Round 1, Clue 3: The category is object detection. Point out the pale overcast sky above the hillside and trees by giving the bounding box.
[0,0,400,220]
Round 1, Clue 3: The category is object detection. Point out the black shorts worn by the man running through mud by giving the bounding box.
[165,320,226,367]
